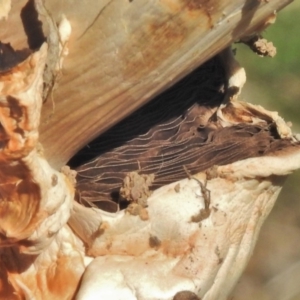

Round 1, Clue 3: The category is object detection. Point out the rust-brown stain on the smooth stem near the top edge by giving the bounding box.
[118,0,218,82]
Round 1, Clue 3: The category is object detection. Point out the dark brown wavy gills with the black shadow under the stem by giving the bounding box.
[70,58,290,212]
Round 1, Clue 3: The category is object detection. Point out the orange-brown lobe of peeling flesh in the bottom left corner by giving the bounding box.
[0,233,84,300]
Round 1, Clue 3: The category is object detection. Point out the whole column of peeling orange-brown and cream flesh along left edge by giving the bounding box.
[0,40,84,299]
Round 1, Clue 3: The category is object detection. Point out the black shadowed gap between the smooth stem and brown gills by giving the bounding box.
[69,59,224,168]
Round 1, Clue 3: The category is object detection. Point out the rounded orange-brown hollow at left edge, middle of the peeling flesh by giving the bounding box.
[0,161,46,245]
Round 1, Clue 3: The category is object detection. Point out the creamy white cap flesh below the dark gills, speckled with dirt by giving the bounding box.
[69,150,300,300]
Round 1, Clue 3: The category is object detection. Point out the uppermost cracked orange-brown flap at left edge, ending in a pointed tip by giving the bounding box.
[0,45,47,160]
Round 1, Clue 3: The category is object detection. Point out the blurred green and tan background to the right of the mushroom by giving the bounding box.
[233,1,300,300]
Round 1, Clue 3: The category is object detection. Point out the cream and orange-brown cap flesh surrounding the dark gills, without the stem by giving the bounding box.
[0,40,300,300]
